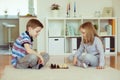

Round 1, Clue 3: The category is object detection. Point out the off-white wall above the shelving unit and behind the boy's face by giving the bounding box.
[37,0,112,51]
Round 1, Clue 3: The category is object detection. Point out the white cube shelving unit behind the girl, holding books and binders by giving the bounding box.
[46,17,117,67]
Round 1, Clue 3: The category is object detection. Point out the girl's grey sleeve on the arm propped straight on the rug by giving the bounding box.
[96,38,105,66]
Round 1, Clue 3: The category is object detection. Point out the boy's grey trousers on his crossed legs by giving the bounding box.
[16,53,49,69]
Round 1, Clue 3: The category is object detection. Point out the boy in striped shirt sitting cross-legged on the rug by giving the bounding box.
[11,19,49,69]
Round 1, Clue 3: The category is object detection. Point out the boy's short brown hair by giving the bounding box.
[26,19,43,30]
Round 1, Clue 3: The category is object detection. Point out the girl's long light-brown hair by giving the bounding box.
[79,22,100,44]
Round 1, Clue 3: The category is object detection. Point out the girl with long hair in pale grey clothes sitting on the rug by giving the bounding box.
[69,22,105,69]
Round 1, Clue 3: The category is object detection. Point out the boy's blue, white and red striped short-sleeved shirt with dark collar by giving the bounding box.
[11,31,33,66]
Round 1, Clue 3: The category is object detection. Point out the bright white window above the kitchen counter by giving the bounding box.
[0,0,37,15]
